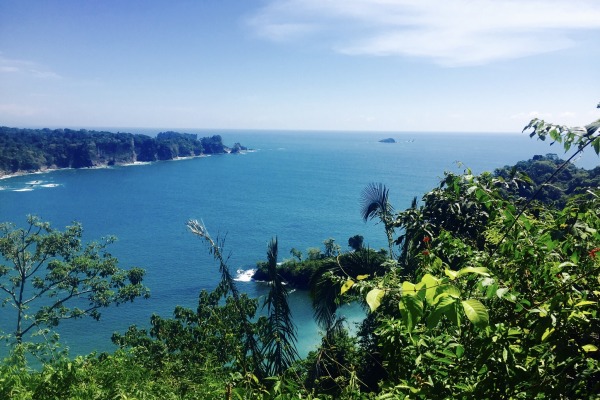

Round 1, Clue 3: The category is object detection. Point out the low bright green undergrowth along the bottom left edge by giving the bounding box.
[0,350,231,400]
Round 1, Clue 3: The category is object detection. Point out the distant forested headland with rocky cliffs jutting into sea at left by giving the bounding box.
[0,127,246,176]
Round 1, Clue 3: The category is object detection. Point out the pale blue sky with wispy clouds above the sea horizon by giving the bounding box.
[0,0,600,133]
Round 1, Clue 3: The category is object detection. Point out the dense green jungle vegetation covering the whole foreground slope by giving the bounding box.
[0,110,600,399]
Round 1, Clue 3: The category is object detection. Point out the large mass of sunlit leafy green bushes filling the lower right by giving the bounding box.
[340,110,600,398]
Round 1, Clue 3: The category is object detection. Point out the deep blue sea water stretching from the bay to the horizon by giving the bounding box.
[0,129,598,355]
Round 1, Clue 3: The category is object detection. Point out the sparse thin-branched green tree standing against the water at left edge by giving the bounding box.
[0,216,149,343]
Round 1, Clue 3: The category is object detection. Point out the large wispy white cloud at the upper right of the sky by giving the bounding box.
[249,0,600,66]
